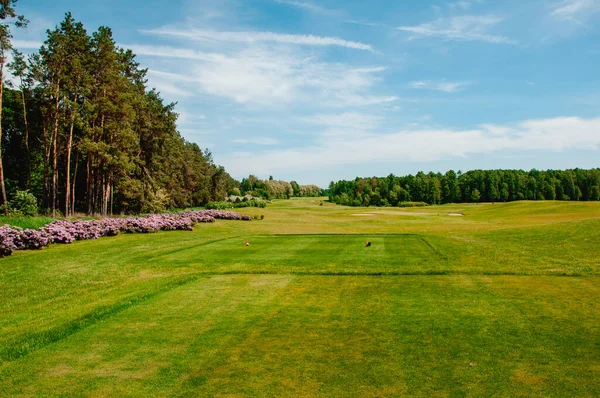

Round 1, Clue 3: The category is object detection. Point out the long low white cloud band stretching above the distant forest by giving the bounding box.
[224,114,600,175]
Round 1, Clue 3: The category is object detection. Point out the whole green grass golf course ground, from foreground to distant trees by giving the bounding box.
[0,199,600,397]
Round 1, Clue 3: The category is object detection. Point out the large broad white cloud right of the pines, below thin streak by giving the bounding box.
[135,45,398,107]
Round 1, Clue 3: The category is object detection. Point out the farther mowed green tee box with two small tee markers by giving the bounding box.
[149,234,443,274]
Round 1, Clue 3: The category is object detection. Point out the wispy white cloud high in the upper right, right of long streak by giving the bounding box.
[397,15,516,44]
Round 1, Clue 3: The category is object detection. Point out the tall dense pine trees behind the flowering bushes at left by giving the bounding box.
[0,8,236,216]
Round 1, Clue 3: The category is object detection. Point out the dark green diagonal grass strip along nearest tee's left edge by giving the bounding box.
[0,275,198,365]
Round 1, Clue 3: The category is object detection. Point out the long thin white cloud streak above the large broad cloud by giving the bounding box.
[140,27,375,52]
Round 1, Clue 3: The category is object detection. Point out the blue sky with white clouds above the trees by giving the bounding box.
[14,0,600,187]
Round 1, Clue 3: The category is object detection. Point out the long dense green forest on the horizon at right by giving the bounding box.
[329,169,600,206]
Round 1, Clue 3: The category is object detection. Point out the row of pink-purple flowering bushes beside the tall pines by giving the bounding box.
[0,210,251,257]
